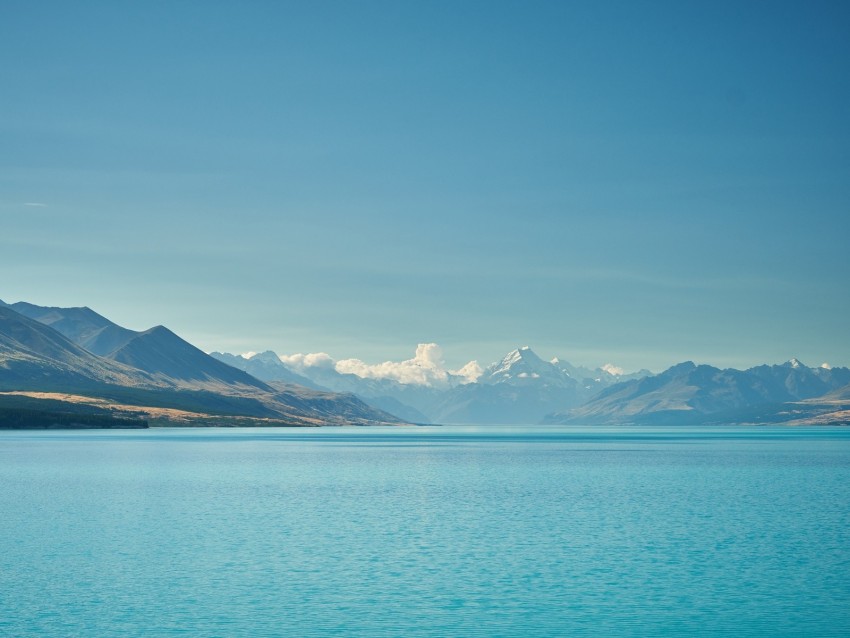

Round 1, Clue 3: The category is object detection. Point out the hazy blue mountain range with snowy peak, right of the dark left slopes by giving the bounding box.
[212,346,850,424]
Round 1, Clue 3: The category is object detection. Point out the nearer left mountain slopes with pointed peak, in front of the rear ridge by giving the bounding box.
[0,305,399,425]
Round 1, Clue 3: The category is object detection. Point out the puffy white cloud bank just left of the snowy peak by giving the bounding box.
[280,343,482,388]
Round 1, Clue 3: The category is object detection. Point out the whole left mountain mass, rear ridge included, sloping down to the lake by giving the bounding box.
[0,302,401,425]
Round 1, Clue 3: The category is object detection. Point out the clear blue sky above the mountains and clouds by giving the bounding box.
[0,0,850,371]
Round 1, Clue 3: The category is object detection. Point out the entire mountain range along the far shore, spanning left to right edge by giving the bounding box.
[0,302,850,425]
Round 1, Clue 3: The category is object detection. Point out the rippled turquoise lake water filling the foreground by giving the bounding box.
[0,427,850,636]
